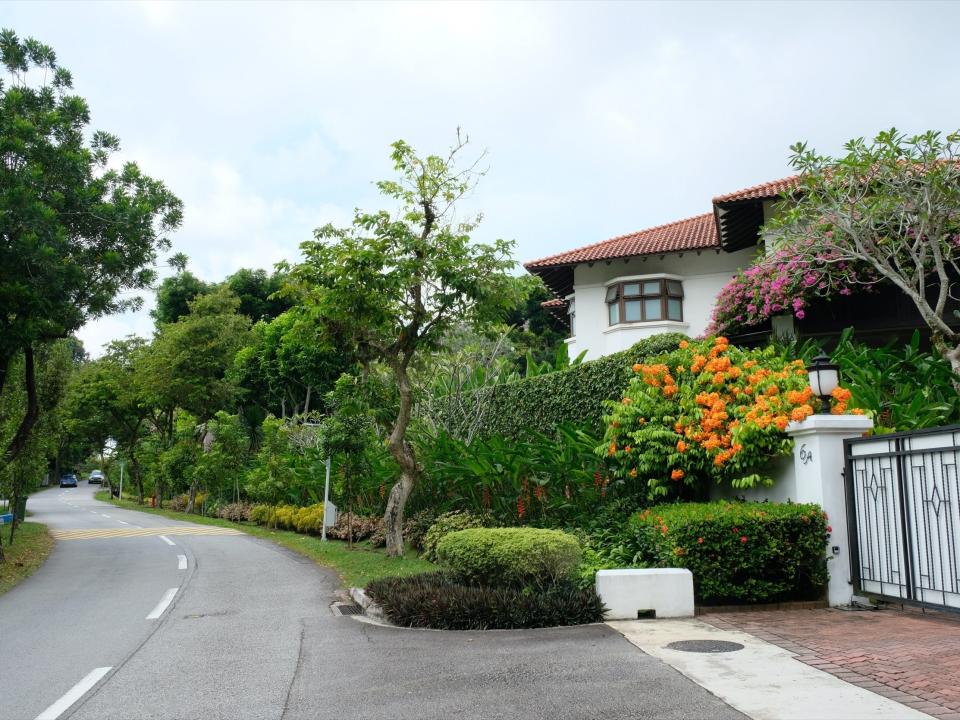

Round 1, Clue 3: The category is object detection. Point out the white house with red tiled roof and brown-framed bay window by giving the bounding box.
[524,176,796,359]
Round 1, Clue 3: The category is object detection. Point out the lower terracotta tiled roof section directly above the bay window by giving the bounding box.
[523,213,720,270]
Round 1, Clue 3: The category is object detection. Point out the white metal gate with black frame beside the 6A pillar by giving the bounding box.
[844,426,960,610]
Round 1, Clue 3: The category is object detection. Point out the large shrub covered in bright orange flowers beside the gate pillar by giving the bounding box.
[597,337,857,496]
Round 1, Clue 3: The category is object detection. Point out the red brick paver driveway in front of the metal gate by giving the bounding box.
[700,609,960,720]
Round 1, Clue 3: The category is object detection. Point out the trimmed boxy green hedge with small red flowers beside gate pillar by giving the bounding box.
[631,502,830,605]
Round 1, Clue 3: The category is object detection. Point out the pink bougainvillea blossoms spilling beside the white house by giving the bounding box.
[706,240,876,335]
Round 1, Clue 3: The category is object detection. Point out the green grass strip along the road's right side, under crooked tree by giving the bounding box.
[95,490,437,587]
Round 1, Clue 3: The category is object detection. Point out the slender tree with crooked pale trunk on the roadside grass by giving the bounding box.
[293,132,517,555]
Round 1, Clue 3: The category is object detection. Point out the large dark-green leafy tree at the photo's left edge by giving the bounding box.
[0,30,182,461]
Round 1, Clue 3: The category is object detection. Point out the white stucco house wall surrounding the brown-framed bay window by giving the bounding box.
[567,248,756,360]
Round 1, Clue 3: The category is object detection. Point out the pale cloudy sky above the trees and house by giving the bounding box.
[7,1,960,356]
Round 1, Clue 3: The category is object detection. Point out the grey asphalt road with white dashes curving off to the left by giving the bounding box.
[0,483,743,720]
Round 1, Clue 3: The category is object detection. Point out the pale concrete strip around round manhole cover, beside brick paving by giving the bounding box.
[607,611,931,720]
